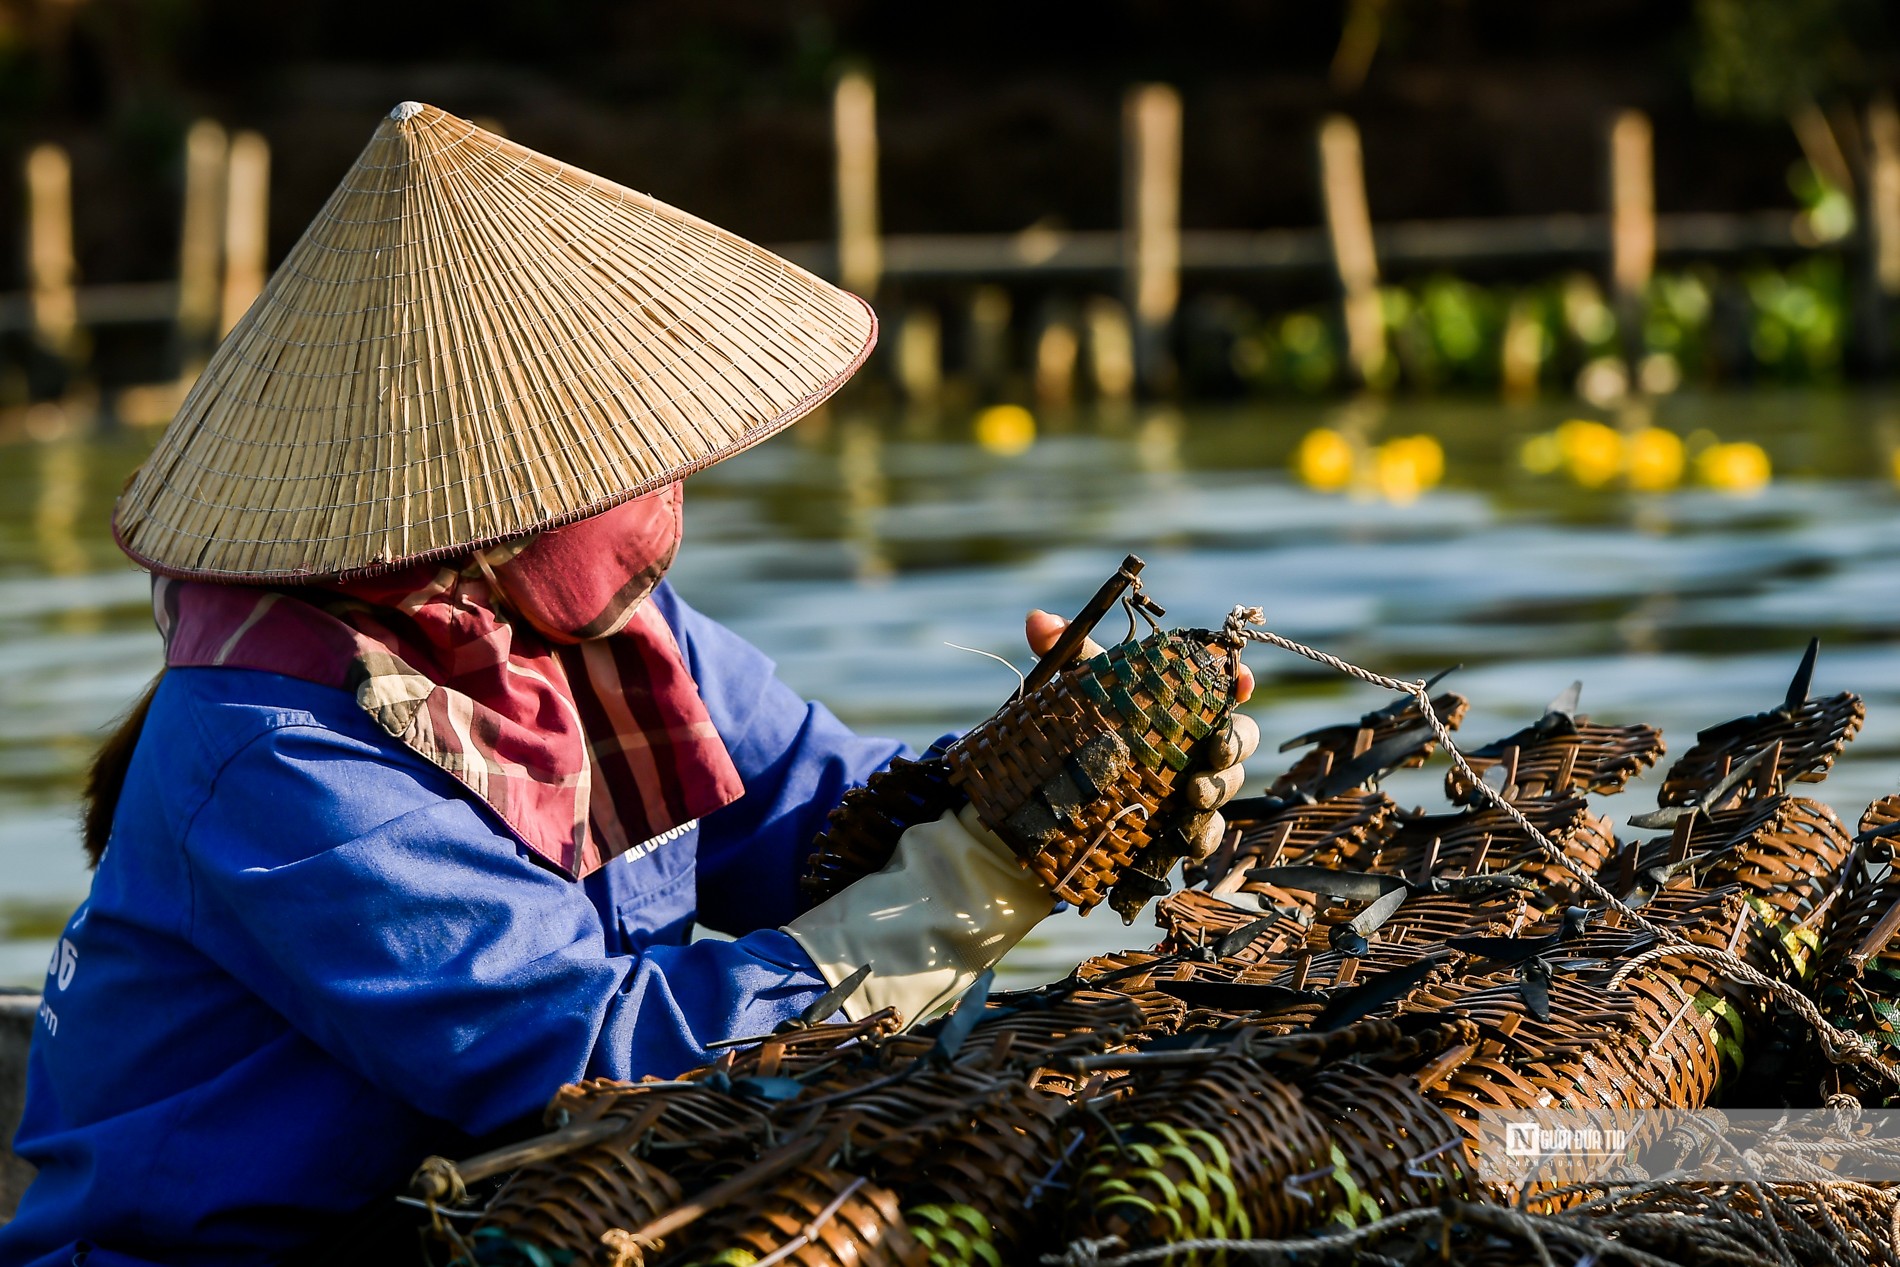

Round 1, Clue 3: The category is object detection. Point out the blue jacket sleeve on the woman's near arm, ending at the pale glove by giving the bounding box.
[184,724,825,1136]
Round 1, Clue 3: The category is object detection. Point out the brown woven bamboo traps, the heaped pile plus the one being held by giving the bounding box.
[414,633,1900,1267]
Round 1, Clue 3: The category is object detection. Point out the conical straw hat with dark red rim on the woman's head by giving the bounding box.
[112,103,878,581]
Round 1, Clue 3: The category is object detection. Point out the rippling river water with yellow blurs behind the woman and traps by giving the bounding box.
[0,393,1900,984]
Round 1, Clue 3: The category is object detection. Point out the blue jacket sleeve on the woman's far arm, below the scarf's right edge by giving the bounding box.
[654,585,906,935]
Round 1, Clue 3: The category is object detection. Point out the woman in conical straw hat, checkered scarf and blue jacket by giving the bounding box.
[0,103,1250,1267]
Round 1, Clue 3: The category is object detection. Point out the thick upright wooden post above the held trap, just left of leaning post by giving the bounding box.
[1123,84,1182,389]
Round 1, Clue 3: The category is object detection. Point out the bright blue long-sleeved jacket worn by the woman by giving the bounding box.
[0,587,901,1267]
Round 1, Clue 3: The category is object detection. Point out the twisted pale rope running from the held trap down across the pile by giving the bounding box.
[1224,606,1900,1087]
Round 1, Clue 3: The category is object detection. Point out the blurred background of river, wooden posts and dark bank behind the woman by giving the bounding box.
[0,0,1900,984]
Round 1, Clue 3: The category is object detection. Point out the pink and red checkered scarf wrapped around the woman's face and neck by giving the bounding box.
[152,484,745,878]
